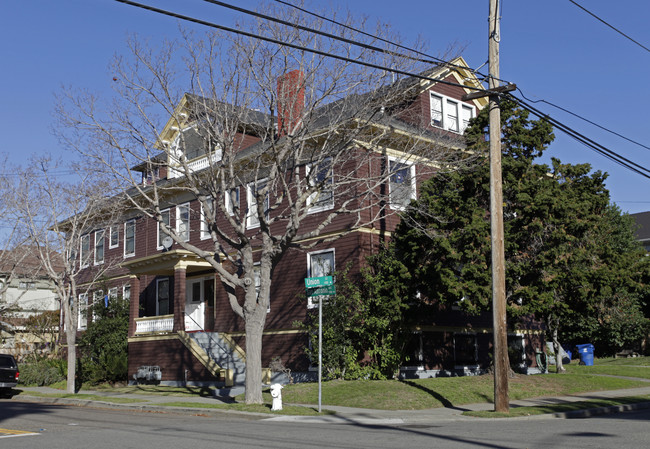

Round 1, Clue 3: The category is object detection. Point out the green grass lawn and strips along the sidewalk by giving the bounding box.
[15,357,650,417]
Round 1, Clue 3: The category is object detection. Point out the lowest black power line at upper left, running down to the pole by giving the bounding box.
[115,0,485,92]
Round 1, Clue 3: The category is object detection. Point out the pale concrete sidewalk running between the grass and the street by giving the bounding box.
[11,386,650,426]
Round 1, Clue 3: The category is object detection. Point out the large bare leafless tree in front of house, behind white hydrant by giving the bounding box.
[59,2,480,403]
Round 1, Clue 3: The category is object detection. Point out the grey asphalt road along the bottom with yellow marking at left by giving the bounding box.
[0,399,650,449]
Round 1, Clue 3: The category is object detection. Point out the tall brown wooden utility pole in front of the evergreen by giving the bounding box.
[488,0,510,413]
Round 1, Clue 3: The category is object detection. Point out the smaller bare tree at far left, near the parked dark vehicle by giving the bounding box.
[12,157,124,393]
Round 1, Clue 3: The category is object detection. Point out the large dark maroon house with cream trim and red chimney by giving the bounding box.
[71,58,534,385]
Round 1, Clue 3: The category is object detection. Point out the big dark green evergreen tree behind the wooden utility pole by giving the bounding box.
[394,101,648,371]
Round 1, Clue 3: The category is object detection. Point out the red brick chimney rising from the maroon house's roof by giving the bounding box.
[278,70,305,137]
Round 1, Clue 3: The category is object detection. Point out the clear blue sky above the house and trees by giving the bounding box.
[0,0,650,213]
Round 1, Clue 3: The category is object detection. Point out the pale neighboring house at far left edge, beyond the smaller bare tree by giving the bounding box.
[0,247,60,360]
